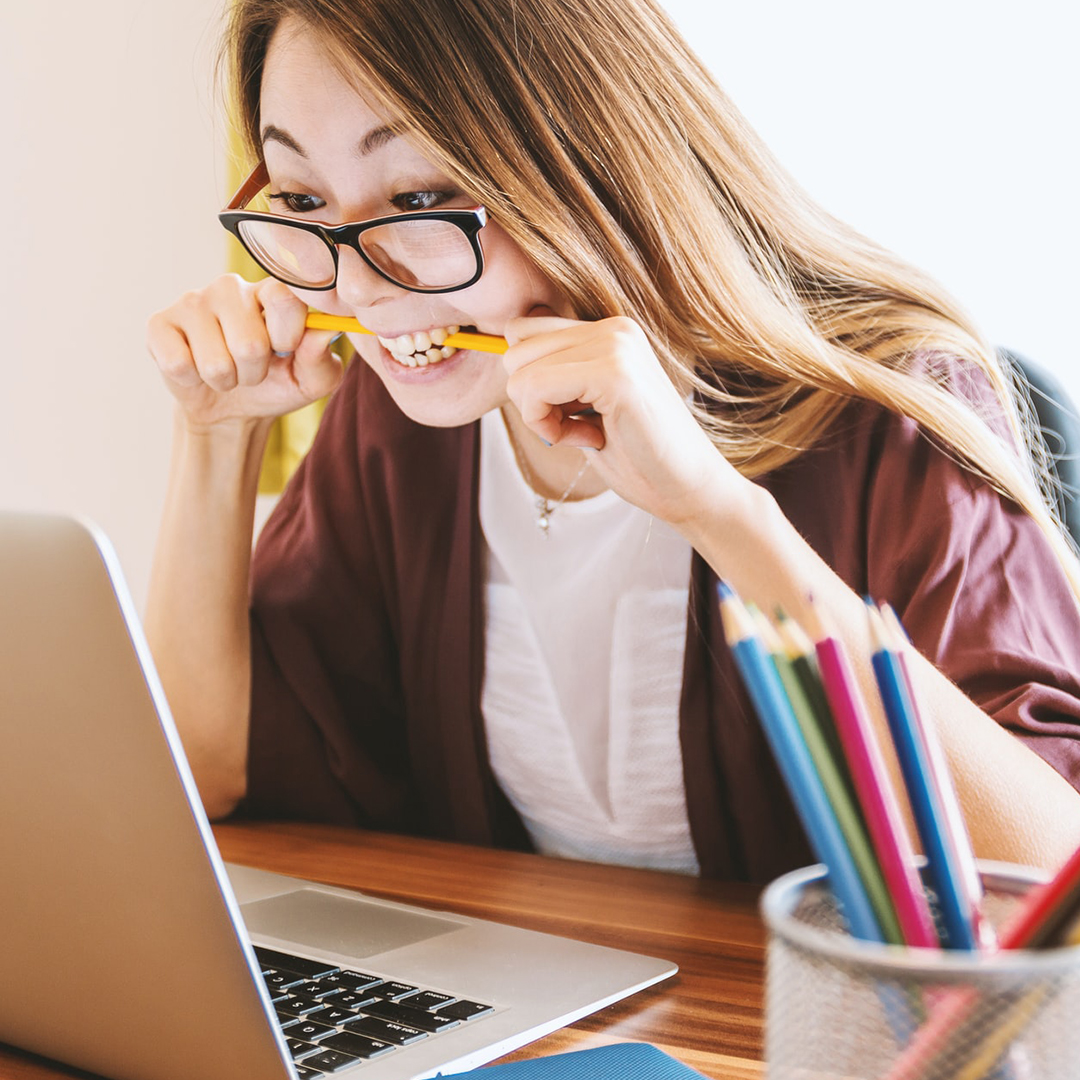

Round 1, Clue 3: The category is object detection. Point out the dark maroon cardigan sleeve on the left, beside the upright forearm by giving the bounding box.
[242,365,416,829]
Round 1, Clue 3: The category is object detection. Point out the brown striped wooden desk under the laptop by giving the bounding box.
[0,824,765,1080]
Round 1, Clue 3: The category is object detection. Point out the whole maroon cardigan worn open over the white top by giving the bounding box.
[243,363,1080,881]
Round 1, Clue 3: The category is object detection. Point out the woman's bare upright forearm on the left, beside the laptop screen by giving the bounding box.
[146,416,269,818]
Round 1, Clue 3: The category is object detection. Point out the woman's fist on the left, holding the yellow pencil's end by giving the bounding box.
[147,274,341,429]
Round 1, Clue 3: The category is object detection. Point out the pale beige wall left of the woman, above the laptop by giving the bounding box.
[0,0,225,603]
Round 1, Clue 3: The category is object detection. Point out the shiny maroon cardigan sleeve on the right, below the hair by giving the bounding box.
[766,362,1080,788]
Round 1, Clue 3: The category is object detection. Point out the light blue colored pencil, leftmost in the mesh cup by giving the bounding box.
[717,581,883,942]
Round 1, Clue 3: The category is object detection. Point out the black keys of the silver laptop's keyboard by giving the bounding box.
[254,945,495,1080]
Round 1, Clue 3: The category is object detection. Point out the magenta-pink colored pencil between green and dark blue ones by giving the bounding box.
[807,611,940,948]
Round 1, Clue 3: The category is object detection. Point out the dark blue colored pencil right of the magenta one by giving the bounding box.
[866,599,980,949]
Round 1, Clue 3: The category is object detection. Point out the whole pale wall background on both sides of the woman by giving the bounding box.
[0,0,1080,603]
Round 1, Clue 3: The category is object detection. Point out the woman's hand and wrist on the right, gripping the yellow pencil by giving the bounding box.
[504,308,750,531]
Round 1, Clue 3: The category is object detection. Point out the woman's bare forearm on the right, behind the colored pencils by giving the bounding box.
[684,484,1080,868]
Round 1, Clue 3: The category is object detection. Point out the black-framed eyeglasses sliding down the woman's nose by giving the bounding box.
[218,162,487,293]
